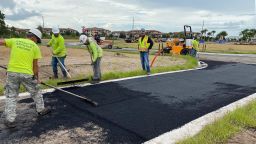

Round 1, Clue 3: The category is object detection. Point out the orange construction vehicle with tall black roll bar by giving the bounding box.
[163,25,193,55]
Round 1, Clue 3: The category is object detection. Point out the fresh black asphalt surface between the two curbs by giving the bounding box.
[2,61,256,143]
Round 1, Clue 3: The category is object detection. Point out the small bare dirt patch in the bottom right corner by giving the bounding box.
[227,129,256,144]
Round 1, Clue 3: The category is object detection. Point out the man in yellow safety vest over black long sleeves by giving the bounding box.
[138,28,154,75]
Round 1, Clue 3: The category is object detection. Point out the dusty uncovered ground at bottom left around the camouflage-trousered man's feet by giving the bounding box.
[0,99,106,144]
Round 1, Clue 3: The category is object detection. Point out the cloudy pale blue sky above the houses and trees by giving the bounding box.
[0,0,256,35]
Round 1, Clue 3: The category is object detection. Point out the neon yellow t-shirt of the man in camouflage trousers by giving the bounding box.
[5,38,42,75]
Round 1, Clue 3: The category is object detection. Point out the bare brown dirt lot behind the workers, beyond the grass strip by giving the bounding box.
[0,46,186,85]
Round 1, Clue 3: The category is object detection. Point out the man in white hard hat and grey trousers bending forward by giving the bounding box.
[79,35,103,83]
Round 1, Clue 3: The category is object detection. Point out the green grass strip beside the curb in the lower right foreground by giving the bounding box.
[178,101,256,144]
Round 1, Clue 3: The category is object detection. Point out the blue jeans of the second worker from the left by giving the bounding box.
[52,56,67,78]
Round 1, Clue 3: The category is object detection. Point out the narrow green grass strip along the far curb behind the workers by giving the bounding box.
[0,56,197,95]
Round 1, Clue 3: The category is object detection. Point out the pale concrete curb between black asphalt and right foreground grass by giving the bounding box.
[144,90,256,144]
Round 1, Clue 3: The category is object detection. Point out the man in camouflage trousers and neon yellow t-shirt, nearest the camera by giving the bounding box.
[0,29,50,128]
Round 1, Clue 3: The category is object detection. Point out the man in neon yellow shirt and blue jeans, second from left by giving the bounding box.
[47,27,67,78]
